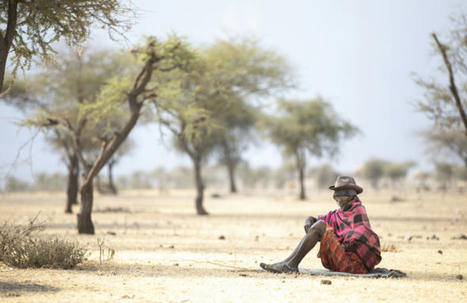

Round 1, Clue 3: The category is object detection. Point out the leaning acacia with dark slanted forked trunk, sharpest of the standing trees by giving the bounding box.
[30,36,196,234]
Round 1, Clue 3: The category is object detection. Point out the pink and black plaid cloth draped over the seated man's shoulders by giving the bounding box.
[318,198,381,272]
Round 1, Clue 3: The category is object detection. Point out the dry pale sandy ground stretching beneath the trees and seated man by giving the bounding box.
[0,191,467,302]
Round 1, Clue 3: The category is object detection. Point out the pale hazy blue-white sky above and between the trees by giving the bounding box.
[0,0,466,183]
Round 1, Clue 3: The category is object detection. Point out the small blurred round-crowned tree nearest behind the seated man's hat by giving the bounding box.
[264,97,357,200]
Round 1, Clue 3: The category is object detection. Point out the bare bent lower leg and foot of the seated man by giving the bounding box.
[260,221,326,273]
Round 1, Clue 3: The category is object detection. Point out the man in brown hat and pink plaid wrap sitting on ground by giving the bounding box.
[260,176,381,274]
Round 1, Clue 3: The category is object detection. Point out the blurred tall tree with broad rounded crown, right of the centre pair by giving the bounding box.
[203,38,293,193]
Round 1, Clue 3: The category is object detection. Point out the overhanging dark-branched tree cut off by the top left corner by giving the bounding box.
[0,0,134,96]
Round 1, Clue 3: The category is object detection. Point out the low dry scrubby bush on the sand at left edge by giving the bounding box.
[0,221,86,269]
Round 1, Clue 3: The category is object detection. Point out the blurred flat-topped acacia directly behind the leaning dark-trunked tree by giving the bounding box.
[5,49,130,213]
